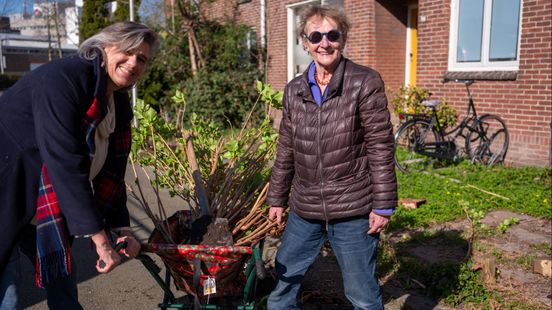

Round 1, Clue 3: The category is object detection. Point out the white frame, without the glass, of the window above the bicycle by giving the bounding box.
[448,0,523,71]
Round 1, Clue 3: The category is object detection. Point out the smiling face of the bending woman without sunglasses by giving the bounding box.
[104,42,151,92]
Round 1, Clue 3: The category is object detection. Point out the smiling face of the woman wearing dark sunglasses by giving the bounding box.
[304,16,345,70]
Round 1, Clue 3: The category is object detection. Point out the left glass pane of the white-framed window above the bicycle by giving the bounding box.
[456,0,485,62]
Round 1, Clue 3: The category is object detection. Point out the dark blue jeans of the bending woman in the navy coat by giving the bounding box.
[0,226,82,310]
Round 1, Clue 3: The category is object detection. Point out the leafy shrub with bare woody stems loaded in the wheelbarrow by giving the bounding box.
[133,86,283,245]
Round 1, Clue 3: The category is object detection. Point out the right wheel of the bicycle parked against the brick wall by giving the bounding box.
[466,114,510,166]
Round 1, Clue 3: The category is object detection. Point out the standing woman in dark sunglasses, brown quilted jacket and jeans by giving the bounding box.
[267,6,397,310]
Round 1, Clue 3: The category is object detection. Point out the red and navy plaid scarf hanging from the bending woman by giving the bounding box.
[36,99,130,287]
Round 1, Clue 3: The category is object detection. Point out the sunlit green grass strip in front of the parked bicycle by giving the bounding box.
[388,161,552,231]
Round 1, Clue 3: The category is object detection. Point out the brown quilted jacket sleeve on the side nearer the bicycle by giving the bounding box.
[360,73,397,209]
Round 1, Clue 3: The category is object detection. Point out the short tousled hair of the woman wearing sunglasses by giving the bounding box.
[296,5,351,40]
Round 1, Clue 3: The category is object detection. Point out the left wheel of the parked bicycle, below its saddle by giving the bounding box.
[395,119,441,173]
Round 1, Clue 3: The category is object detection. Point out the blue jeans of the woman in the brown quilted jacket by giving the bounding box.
[268,212,383,310]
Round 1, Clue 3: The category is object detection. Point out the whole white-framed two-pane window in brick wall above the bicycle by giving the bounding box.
[449,0,521,71]
